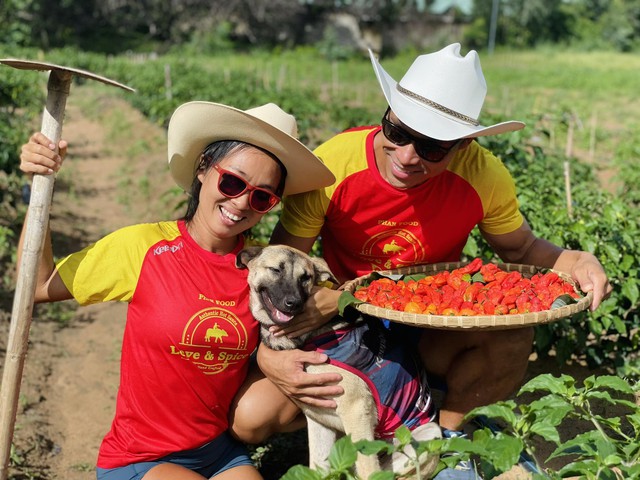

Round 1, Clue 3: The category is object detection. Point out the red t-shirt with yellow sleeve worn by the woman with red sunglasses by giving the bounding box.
[57,221,258,468]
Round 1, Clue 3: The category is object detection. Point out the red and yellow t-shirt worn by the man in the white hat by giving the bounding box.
[280,127,523,282]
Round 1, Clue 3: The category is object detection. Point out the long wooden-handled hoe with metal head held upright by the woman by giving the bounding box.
[0,58,133,480]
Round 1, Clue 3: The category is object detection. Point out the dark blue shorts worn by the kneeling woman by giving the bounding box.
[96,432,253,480]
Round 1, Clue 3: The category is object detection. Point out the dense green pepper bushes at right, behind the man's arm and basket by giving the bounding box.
[464,117,640,373]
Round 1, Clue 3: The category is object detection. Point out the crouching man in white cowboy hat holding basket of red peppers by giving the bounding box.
[232,43,611,478]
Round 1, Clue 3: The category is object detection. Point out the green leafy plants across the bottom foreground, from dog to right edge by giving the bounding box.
[282,374,640,480]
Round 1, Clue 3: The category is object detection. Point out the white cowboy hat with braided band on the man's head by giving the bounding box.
[369,43,524,140]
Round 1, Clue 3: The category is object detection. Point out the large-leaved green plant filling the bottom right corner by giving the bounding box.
[468,374,640,480]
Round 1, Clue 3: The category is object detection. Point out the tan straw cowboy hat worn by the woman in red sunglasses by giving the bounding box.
[167,101,335,195]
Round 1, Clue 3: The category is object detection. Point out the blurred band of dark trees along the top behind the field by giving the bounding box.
[0,0,640,54]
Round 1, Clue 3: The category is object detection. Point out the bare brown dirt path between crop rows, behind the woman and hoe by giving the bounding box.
[0,86,616,480]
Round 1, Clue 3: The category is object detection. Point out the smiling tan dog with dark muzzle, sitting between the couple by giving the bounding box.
[236,245,441,479]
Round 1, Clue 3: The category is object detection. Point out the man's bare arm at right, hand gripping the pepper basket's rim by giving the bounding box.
[482,220,612,310]
